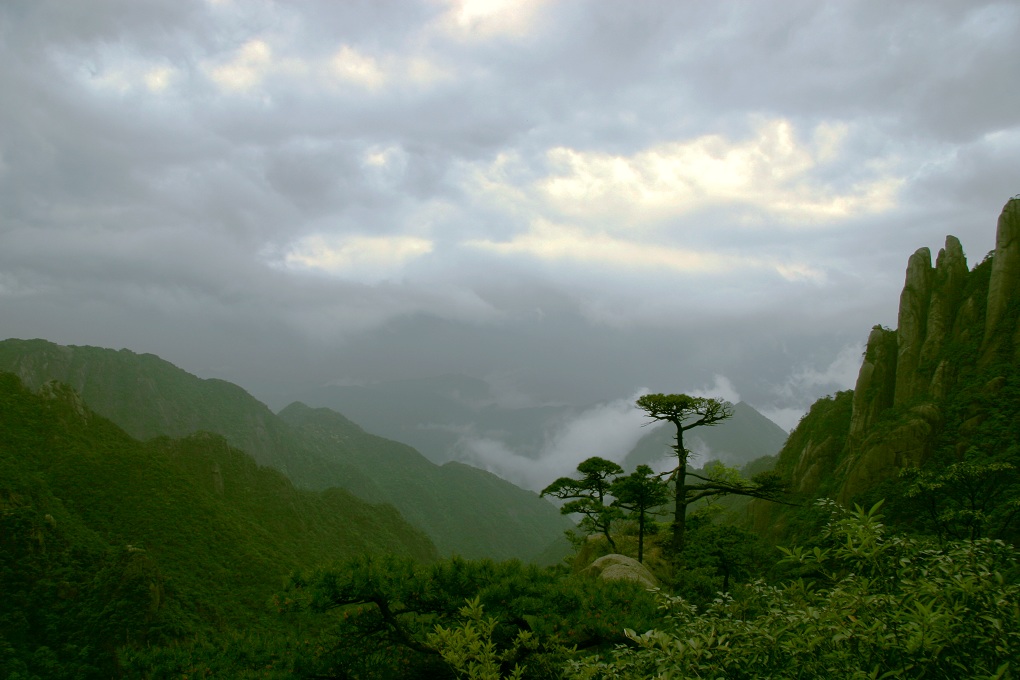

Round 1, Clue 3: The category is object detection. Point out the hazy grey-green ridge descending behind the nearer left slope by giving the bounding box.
[0,339,570,559]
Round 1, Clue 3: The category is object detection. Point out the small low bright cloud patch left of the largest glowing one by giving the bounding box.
[278,233,432,280]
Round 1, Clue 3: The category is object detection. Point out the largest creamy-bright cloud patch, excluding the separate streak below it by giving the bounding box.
[541,118,902,221]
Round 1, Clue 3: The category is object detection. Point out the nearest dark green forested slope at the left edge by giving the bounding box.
[0,372,438,677]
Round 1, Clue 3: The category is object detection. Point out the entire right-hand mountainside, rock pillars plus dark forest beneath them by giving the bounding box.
[750,198,1020,538]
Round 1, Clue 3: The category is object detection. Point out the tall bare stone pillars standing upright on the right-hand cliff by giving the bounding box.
[839,199,1020,500]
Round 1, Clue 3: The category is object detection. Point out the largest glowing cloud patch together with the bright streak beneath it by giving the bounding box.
[463,118,903,285]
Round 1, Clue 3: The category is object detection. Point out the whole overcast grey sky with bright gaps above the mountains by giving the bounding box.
[0,0,1020,427]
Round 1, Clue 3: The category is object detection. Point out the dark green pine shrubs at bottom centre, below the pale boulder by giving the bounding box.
[278,557,656,678]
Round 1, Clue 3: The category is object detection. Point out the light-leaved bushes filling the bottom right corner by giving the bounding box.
[568,501,1020,680]
